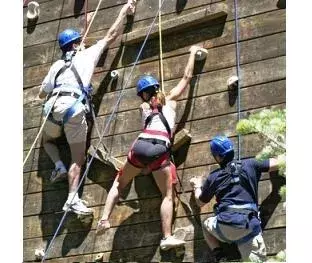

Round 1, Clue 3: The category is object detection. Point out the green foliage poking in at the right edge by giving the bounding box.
[236,109,286,200]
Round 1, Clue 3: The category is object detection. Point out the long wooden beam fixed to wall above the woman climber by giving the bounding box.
[122,9,227,45]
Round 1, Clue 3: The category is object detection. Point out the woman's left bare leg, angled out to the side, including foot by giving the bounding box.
[97,161,142,234]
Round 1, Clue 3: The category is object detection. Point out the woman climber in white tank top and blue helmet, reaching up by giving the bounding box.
[97,46,206,250]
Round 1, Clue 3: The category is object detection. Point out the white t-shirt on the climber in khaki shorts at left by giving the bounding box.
[40,40,107,116]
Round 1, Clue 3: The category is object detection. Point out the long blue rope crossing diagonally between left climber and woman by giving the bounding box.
[41,0,165,262]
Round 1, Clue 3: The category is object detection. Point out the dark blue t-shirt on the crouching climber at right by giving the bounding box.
[199,159,270,227]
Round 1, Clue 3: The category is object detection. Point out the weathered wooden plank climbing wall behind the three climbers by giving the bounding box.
[23,0,286,263]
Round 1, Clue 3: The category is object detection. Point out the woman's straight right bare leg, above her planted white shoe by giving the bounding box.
[153,166,173,238]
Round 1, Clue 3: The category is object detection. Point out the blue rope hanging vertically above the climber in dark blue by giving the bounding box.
[234,0,241,160]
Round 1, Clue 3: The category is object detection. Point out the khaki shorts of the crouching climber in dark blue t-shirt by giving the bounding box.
[203,216,266,262]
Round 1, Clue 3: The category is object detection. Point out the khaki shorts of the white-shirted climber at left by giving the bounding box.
[44,112,88,144]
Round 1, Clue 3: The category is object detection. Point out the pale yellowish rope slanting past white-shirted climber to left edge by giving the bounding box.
[23,0,103,167]
